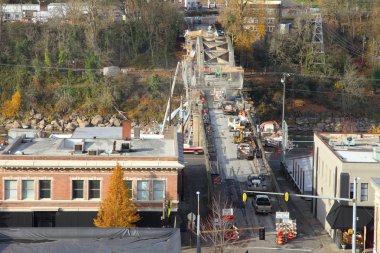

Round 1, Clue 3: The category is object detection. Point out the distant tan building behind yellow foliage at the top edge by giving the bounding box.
[245,0,282,34]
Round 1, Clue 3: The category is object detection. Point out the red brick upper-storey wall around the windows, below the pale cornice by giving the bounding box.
[0,169,178,208]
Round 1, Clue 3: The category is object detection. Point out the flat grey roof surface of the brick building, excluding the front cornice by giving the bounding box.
[2,127,178,157]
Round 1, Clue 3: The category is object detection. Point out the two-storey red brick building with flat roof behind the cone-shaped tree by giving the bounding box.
[0,122,184,227]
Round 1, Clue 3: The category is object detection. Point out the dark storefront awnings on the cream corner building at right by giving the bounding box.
[326,201,374,229]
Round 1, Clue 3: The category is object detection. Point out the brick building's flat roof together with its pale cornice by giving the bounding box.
[0,127,183,169]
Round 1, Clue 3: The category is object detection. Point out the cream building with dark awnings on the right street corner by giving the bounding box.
[313,132,380,248]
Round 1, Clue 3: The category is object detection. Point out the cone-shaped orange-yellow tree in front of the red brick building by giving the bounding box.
[94,164,140,227]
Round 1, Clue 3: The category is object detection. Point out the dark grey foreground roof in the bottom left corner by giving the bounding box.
[0,227,181,253]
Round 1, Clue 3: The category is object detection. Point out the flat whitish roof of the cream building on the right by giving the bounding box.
[315,133,380,163]
